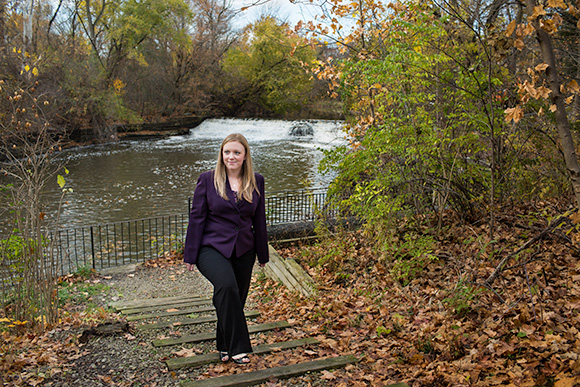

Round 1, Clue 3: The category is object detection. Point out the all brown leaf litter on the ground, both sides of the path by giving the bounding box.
[0,205,580,387]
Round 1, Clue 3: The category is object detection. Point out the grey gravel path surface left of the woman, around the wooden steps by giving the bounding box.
[44,265,224,387]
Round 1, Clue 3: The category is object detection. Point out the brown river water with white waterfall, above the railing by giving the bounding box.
[1,119,344,228]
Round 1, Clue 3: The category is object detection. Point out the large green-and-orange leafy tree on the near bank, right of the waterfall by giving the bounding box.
[294,1,580,284]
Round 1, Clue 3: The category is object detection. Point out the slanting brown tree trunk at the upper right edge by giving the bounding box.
[526,0,580,208]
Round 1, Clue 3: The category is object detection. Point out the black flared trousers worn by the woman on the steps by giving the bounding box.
[197,247,256,356]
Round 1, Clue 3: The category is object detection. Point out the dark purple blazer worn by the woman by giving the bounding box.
[183,171,269,263]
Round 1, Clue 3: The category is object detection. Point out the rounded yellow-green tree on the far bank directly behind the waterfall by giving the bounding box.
[222,17,315,115]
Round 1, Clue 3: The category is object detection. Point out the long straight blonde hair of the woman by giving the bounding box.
[213,133,260,203]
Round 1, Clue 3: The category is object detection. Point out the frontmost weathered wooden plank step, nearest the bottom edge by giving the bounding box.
[181,355,358,387]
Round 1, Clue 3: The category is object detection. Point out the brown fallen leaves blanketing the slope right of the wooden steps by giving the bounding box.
[253,205,580,387]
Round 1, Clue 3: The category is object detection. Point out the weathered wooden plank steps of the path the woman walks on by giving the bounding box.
[111,297,406,387]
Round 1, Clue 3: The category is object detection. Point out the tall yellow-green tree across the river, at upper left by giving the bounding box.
[46,0,190,136]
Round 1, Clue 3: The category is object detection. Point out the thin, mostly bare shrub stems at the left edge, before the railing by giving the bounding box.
[0,83,64,330]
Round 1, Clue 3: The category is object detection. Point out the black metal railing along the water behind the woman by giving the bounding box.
[52,189,336,274]
